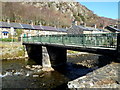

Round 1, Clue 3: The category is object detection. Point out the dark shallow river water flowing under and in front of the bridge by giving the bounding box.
[0,55,100,90]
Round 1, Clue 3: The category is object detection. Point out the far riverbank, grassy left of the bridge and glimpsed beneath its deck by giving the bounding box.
[0,42,88,60]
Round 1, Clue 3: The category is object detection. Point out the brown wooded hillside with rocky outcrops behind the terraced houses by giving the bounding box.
[1,2,117,28]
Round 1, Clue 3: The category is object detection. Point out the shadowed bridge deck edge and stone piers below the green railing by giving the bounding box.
[23,43,120,67]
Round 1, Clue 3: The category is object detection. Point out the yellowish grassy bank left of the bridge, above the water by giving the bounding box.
[0,42,24,59]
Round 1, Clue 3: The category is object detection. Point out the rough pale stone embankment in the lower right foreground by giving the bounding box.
[68,63,120,90]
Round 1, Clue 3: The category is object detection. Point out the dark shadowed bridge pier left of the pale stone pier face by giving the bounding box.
[25,45,42,65]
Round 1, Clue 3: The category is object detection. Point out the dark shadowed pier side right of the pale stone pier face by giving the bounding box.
[46,46,67,68]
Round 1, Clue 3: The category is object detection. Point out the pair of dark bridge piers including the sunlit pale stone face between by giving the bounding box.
[25,44,67,67]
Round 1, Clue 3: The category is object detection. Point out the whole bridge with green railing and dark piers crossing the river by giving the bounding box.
[23,33,120,67]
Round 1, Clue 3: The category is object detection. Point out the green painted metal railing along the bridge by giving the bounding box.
[23,33,118,48]
